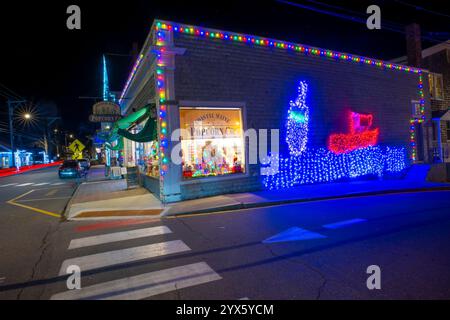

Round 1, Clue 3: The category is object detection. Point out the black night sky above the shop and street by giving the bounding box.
[0,0,450,144]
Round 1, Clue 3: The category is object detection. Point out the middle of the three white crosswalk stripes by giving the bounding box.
[59,240,191,276]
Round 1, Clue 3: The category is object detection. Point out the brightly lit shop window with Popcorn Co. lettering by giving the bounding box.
[180,108,245,179]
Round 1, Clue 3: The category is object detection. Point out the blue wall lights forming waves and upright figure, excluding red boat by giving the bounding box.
[263,81,408,190]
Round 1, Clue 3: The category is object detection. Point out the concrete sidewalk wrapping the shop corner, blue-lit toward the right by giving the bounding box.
[66,167,450,220]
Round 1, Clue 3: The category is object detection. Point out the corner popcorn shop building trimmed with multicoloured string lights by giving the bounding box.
[112,21,431,202]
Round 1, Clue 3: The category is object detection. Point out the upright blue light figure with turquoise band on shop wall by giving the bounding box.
[286,81,309,156]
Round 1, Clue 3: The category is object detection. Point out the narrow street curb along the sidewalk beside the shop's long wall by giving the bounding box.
[164,186,450,218]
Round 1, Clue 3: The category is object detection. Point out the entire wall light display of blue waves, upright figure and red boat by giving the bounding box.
[263,81,408,189]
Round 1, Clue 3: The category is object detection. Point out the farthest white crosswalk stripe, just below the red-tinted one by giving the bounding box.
[69,226,172,250]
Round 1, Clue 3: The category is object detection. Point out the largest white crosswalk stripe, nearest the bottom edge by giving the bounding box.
[50,262,222,300]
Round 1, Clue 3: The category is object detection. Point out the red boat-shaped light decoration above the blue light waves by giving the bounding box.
[328,112,379,154]
